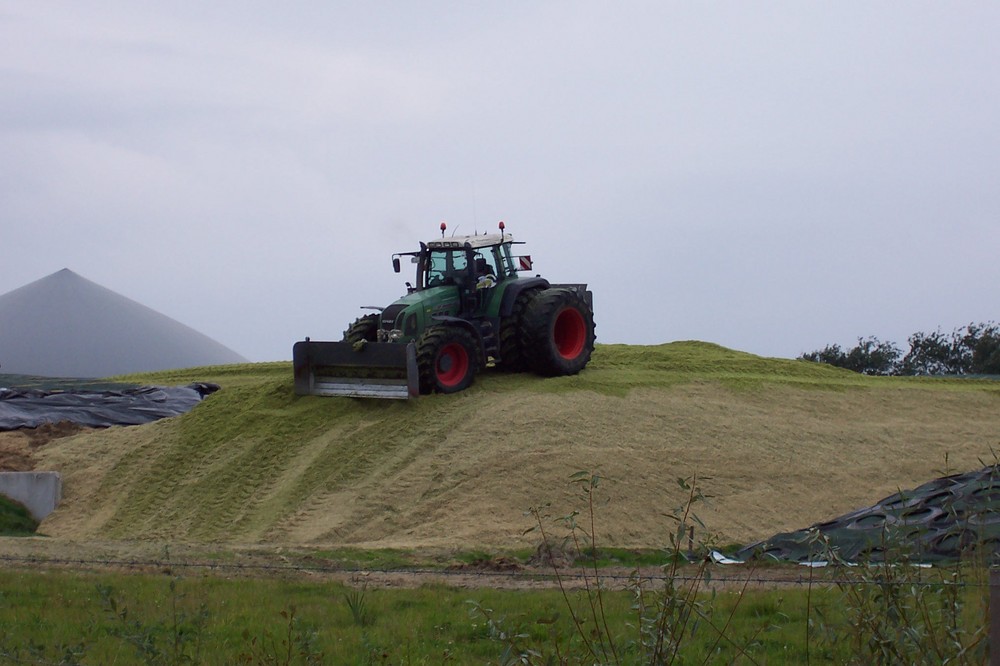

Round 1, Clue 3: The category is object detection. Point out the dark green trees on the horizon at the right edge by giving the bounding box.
[799,322,1000,375]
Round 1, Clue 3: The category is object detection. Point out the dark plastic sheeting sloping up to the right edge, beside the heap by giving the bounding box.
[736,465,1000,564]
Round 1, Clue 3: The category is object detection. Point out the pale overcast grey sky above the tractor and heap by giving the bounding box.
[0,0,1000,361]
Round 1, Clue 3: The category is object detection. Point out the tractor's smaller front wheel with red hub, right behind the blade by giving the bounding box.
[417,326,479,393]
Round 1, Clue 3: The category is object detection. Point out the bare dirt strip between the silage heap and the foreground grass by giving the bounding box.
[0,537,828,590]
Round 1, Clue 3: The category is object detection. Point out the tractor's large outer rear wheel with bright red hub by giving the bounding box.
[523,287,596,377]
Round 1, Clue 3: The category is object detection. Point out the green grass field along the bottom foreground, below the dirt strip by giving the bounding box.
[0,570,986,664]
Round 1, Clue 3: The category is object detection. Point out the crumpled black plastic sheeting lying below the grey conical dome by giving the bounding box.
[0,383,219,430]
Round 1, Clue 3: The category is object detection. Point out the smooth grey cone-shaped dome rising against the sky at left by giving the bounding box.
[0,268,246,377]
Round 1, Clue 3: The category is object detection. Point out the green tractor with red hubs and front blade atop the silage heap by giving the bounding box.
[292,222,595,399]
